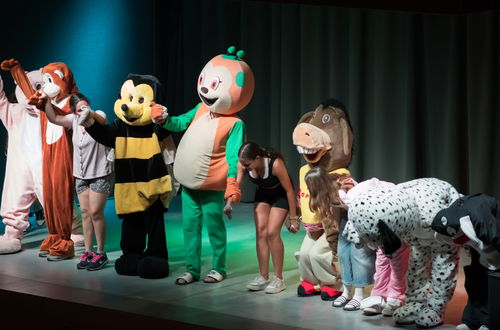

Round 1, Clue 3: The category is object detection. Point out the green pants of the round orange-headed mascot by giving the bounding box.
[182,186,227,279]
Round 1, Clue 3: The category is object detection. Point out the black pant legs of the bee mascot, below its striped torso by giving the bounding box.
[120,199,168,259]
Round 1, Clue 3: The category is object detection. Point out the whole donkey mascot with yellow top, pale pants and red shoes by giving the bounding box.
[293,99,353,300]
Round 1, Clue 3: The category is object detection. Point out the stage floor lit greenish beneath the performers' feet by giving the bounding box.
[0,197,466,330]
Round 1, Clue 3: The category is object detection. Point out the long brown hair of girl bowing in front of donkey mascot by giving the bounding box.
[304,166,346,228]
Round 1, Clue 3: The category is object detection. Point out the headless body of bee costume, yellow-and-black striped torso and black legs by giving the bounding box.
[87,119,172,278]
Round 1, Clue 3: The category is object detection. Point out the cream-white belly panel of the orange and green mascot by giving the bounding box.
[174,112,219,189]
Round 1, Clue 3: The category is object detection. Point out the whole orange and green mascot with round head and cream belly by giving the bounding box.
[154,47,254,284]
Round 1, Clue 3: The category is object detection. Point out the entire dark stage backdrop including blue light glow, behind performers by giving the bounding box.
[0,0,500,198]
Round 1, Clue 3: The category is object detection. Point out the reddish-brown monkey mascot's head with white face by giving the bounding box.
[42,62,78,102]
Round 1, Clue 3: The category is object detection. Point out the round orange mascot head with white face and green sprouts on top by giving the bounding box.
[197,47,255,115]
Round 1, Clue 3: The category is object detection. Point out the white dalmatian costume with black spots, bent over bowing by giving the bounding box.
[343,178,460,328]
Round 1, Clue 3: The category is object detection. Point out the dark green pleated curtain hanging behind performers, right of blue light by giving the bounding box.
[154,0,500,198]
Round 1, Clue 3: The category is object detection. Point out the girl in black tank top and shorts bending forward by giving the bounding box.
[225,142,299,293]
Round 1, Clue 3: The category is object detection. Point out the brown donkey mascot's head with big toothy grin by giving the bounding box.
[292,99,353,171]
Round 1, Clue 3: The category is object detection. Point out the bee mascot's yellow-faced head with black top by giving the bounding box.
[114,74,162,126]
